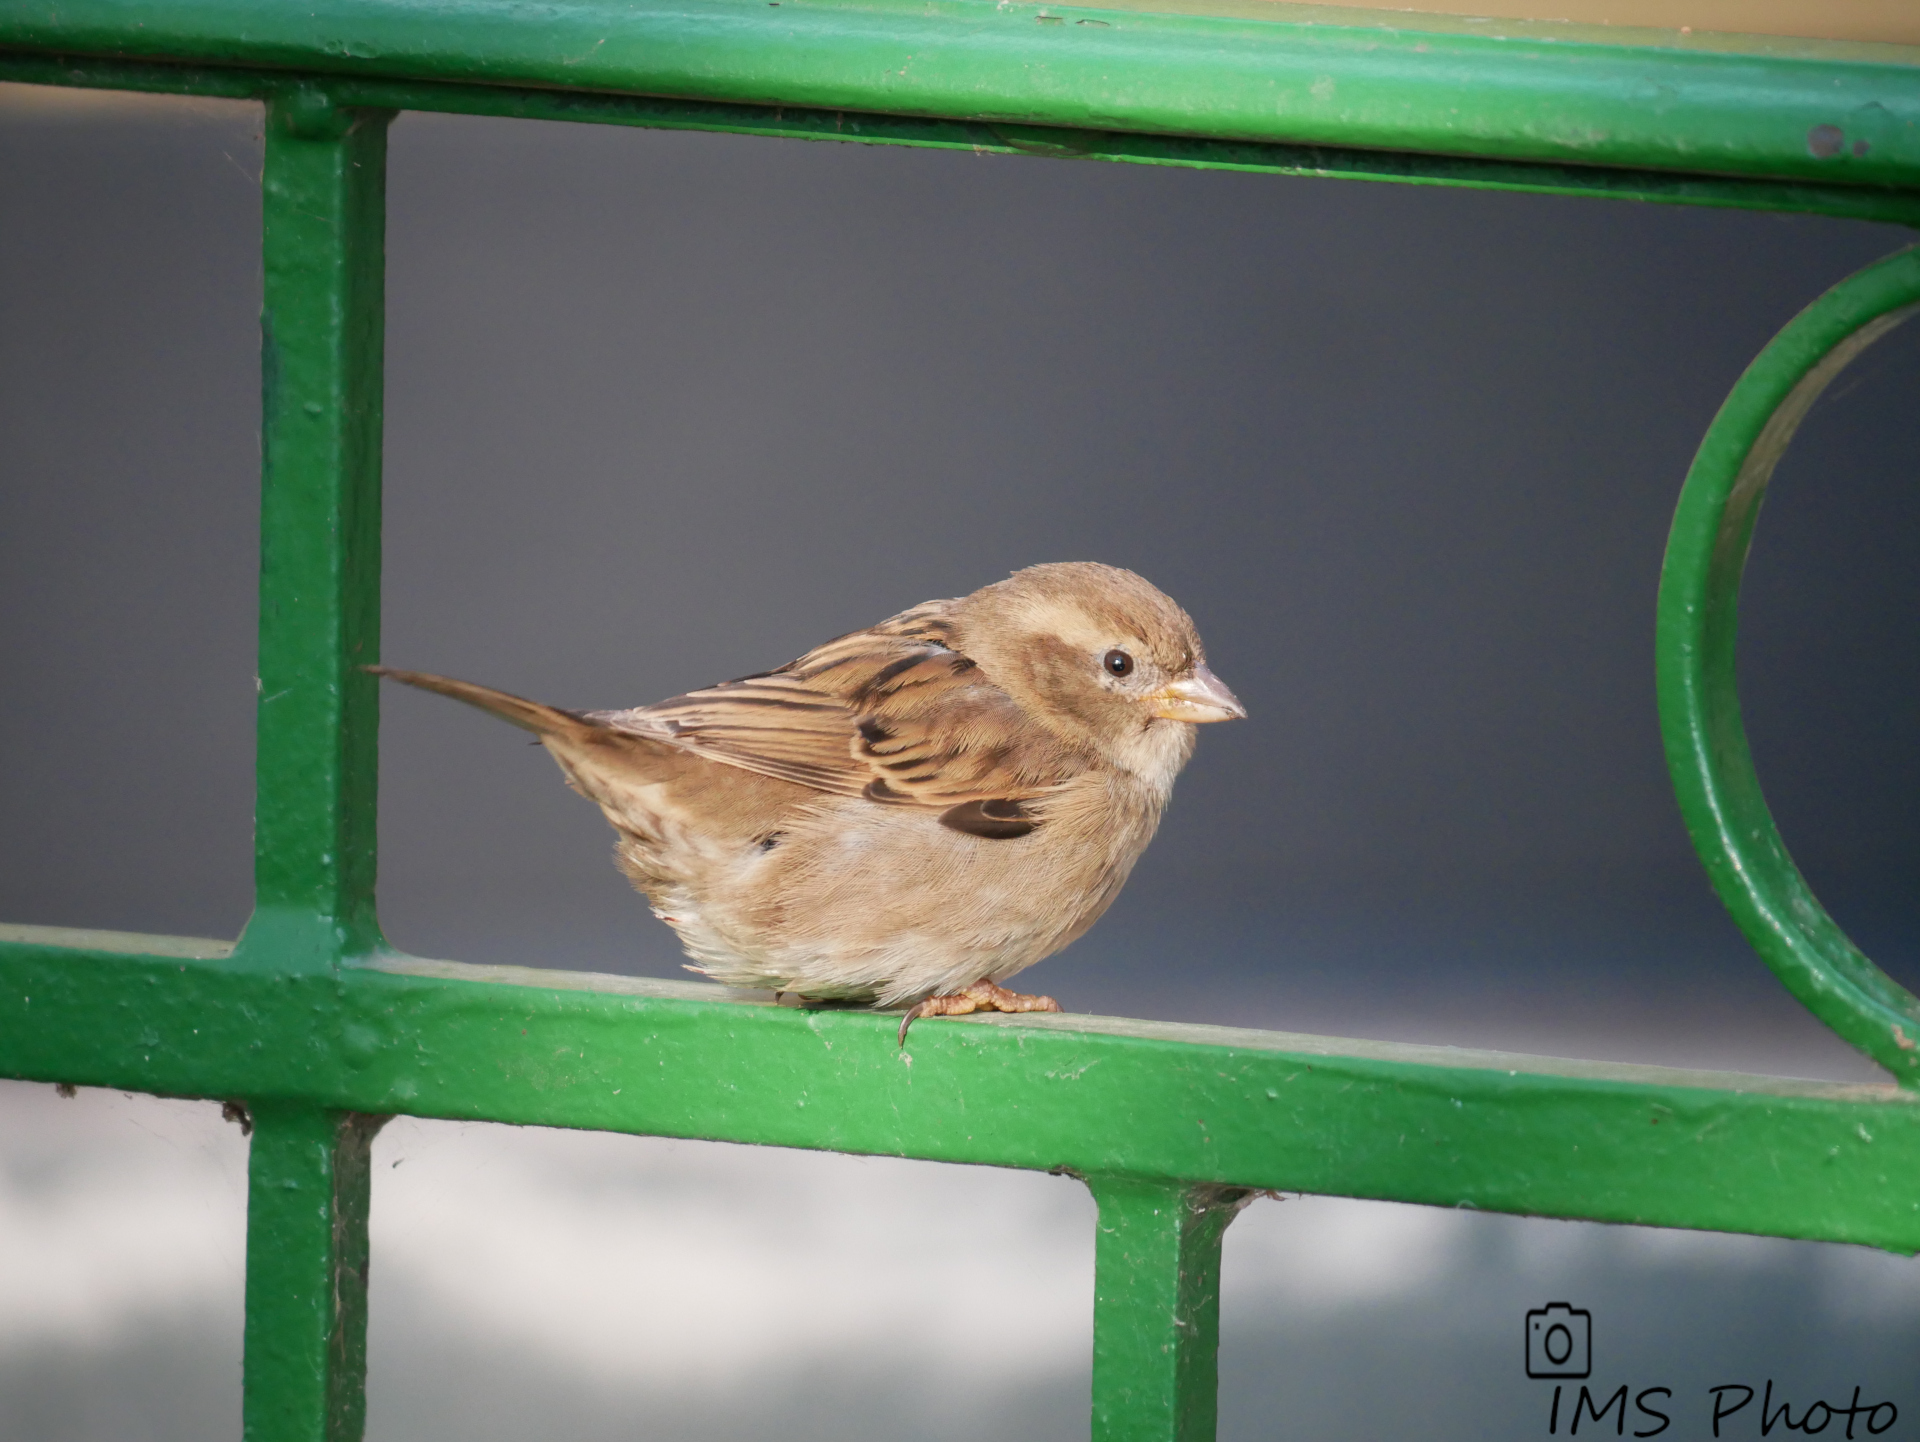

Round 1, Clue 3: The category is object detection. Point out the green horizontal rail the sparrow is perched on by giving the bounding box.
[11,927,1920,1254]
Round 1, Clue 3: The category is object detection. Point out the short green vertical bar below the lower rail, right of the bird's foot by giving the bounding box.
[1089,1177,1250,1442]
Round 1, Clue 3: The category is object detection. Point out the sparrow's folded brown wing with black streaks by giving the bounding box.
[591,603,1077,821]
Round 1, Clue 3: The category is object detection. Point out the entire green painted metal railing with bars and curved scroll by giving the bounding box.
[0,0,1920,1442]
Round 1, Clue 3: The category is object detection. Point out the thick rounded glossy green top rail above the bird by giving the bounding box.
[11,0,1920,188]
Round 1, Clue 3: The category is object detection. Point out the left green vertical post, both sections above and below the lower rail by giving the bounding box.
[232,84,394,1442]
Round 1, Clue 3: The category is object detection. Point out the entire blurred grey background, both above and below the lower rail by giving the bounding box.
[0,90,1920,1442]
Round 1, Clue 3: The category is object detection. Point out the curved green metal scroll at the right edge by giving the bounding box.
[1655,246,1920,1087]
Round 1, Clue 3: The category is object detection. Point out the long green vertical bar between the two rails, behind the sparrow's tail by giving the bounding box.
[242,88,392,970]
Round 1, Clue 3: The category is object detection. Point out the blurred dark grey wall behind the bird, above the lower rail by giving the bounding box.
[0,92,1920,1069]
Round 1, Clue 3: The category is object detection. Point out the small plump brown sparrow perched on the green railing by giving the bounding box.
[369,563,1246,1043]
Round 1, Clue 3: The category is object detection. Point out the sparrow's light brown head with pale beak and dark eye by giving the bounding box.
[954,561,1246,783]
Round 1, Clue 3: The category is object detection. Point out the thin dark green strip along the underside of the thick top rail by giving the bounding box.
[0,52,1920,228]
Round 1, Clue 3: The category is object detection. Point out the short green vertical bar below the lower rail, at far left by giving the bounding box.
[244,1102,386,1442]
